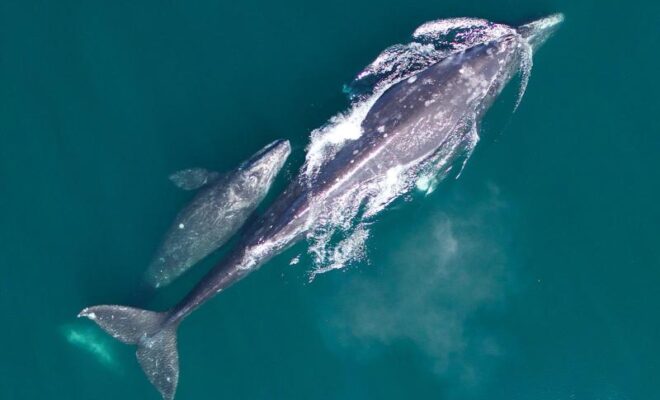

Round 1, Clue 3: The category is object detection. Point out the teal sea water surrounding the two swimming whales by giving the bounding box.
[0,0,660,400]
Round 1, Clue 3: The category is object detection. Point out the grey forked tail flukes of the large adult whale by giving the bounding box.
[78,306,179,400]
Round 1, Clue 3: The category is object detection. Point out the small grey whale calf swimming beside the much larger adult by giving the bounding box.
[145,140,291,288]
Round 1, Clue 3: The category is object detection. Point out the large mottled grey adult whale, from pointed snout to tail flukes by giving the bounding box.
[79,15,562,399]
